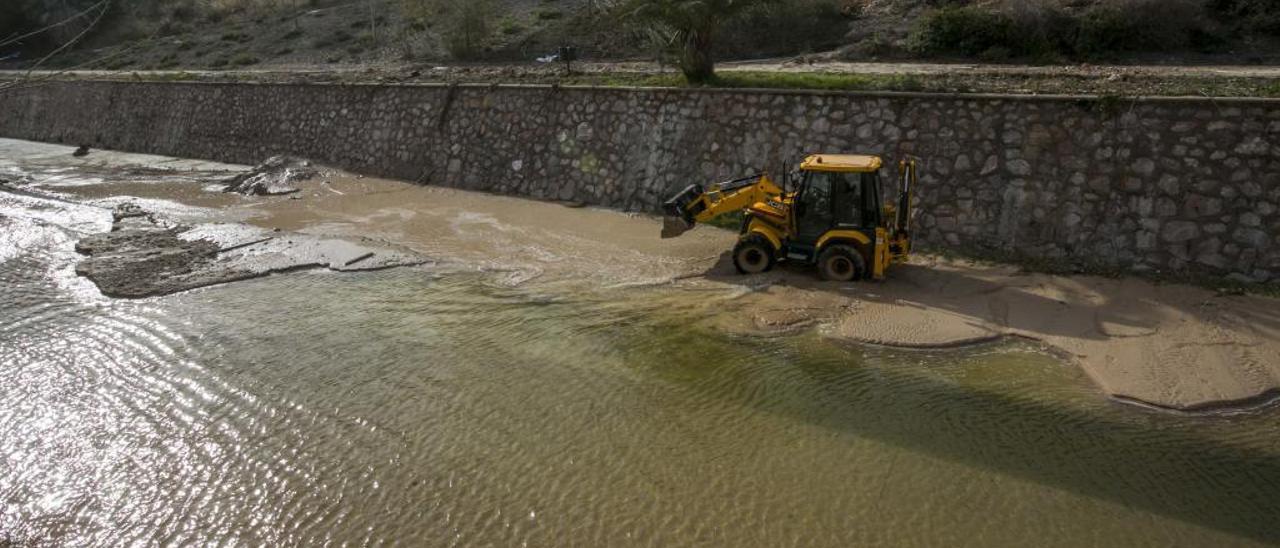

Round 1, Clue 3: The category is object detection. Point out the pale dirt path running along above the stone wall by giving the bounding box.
[0,58,1280,96]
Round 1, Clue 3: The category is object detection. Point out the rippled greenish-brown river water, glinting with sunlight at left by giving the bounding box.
[0,151,1280,547]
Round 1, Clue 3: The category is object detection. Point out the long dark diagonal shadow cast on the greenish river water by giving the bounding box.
[644,316,1280,543]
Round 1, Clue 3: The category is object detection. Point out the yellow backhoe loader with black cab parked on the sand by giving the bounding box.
[662,154,916,282]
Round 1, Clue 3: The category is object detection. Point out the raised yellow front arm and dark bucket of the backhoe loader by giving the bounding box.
[662,173,782,238]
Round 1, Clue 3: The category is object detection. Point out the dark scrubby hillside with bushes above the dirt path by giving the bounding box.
[0,0,1280,70]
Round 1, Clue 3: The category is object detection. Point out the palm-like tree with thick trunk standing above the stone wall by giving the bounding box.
[625,0,767,83]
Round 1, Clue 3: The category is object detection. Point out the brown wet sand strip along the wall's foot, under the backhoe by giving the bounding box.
[0,141,1280,411]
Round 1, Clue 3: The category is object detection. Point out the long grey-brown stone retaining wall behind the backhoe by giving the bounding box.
[0,82,1280,282]
